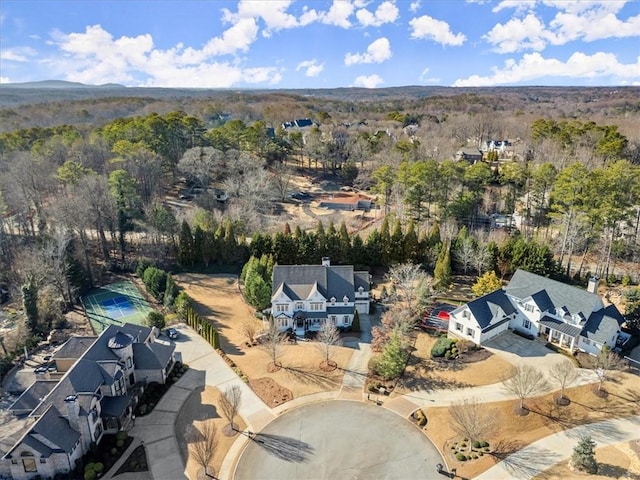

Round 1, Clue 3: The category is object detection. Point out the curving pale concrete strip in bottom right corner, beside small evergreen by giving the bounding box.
[475,415,640,480]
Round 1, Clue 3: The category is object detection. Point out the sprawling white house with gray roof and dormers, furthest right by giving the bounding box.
[449,270,626,354]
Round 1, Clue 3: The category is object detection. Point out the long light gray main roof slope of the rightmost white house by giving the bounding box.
[505,270,604,318]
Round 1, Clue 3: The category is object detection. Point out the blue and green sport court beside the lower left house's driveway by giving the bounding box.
[82,281,153,333]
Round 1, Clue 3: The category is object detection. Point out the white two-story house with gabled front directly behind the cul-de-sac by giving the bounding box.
[271,258,370,335]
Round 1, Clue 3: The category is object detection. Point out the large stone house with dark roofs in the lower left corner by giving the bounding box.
[0,324,175,480]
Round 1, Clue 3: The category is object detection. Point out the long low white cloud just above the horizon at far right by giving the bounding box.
[453,52,640,87]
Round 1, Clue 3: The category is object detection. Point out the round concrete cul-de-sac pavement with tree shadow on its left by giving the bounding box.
[233,401,445,480]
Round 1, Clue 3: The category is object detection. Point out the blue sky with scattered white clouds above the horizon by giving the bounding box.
[0,0,640,88]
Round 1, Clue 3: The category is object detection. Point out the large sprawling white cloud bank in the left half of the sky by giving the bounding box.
[44,23,282,88]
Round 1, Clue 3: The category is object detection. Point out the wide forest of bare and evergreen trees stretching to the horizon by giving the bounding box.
[0,89,640,364]
